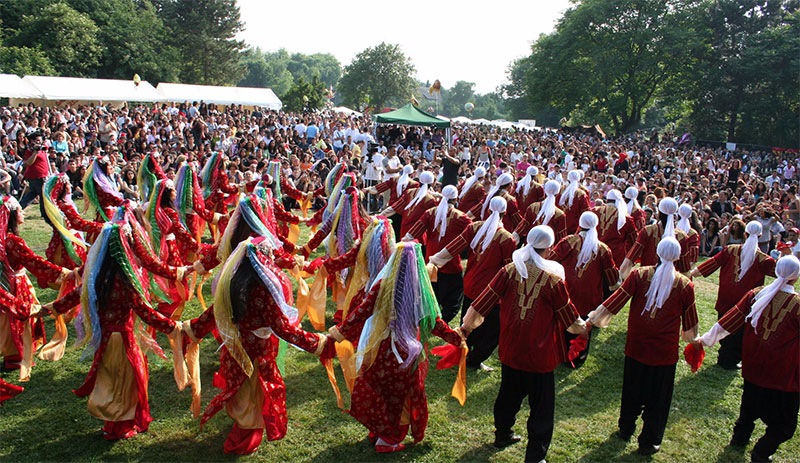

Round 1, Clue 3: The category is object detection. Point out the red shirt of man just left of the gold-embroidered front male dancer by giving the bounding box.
[445,222,517,299]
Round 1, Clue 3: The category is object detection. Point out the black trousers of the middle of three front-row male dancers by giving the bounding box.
[619,356,675,446]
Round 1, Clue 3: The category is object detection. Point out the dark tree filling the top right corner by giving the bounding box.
[678,0,800,146]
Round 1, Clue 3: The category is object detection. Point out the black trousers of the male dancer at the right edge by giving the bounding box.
[733,380,800,461]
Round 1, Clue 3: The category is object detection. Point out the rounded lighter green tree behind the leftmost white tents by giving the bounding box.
[8,2,102,77]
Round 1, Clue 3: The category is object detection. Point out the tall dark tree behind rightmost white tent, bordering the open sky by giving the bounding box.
[154,0,245,85]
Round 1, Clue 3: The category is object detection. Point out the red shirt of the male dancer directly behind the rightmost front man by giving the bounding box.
[697,244,775,315]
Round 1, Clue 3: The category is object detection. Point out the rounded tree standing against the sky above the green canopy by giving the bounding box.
[338,42,416,109]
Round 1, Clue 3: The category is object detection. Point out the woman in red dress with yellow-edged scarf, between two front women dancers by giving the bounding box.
[183,239,333,455]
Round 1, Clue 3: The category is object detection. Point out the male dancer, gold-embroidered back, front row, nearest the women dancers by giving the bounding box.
[461,225,585,462]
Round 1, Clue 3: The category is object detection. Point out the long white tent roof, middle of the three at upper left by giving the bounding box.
[22,76,163,104]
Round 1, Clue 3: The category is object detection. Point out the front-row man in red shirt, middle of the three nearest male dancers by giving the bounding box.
[587,236,697,455]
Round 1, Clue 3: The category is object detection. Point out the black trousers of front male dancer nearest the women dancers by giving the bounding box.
[494,365,556,462]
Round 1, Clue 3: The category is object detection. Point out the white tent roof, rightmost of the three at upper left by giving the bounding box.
[158,82,283,110]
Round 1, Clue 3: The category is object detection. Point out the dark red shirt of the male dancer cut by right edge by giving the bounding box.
[719,290,800,393]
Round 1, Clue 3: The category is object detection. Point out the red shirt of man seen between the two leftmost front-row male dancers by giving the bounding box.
[551,234,619,317]
